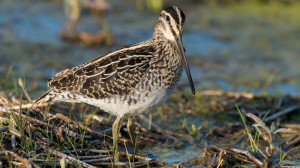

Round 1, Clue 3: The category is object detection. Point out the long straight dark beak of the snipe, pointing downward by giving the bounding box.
[176,36,195,95]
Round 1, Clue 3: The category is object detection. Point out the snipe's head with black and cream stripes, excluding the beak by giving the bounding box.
[155,6,185,40]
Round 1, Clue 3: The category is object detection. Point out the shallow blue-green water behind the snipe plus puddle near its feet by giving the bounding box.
[0,0,300,163]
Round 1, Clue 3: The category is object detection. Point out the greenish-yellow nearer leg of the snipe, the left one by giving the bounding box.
[112,116,122,163]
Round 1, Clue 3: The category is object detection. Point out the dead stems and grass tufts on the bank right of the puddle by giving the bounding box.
[183,91,300,168]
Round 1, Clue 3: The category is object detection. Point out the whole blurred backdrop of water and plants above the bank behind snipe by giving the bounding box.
[0,0,300,97]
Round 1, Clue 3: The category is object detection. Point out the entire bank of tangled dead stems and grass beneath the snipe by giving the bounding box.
[0,86,300,168]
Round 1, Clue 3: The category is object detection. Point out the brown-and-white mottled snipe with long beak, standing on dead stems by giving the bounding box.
[36,6,195,160]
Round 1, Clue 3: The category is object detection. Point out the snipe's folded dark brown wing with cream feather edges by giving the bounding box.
[48,44,155,98]
